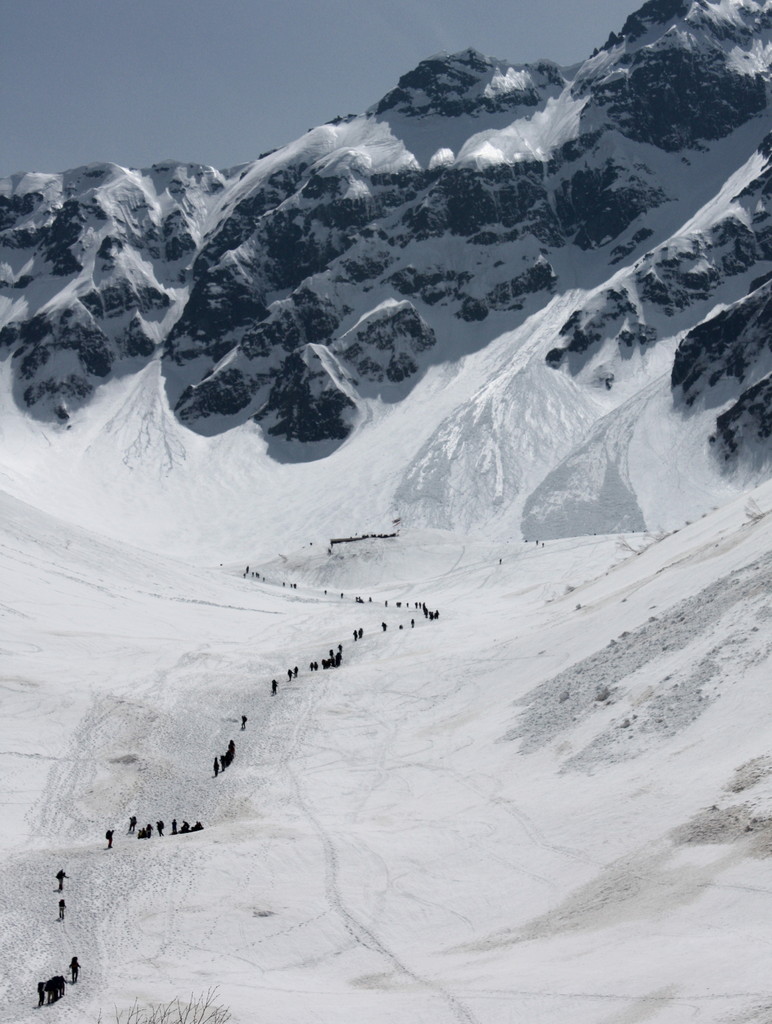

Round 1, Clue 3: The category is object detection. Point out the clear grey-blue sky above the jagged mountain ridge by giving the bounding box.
[0,0,643,176]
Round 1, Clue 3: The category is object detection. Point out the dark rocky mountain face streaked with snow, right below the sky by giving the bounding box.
[0,0,772,485]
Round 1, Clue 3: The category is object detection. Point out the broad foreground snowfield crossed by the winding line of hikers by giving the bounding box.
[0,452,772,1024]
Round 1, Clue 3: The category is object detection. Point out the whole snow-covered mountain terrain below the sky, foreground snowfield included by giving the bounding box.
[0,0,772,1024]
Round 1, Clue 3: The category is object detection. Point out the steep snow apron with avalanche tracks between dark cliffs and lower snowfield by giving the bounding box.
[0,270,747,565]
